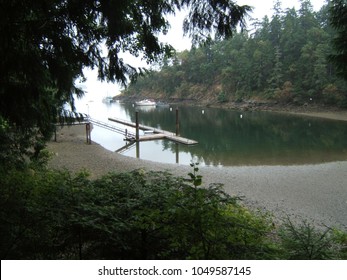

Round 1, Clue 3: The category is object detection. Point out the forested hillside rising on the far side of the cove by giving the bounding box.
[124,0,347,107]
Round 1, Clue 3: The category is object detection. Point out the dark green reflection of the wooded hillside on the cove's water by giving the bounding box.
[121,104,347,165]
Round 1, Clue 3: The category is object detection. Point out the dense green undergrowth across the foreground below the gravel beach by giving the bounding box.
[0,162,347,259]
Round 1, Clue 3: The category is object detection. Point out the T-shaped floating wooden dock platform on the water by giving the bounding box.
[108,118,198,145]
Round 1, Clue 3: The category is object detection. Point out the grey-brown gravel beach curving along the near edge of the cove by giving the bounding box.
[48,125,347,230]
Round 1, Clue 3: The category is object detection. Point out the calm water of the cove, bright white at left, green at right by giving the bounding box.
[78,100,347,166]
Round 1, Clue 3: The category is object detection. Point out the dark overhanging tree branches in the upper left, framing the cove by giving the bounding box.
[0,0,250,165]
